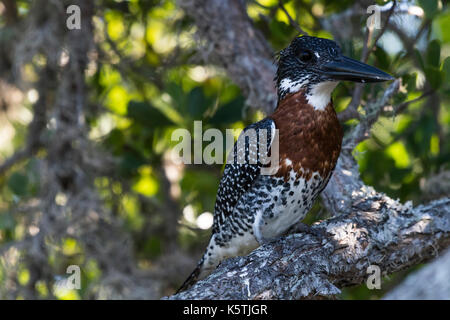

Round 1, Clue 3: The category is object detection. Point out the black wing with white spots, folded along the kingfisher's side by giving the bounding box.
[213,118,275,234]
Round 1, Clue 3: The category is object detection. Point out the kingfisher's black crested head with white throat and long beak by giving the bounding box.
[276,36,394,110]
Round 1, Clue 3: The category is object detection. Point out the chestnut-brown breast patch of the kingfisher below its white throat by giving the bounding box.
[269,91,343,180]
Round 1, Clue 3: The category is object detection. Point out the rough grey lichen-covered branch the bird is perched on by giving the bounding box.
[170,198,450,299]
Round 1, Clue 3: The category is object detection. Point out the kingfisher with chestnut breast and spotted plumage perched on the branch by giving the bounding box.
[177,35,394,293]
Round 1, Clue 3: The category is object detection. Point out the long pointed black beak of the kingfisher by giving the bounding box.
[320,56,394,82]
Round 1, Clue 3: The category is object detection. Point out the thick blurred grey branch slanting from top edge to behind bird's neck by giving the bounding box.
[178,0,277,113]
